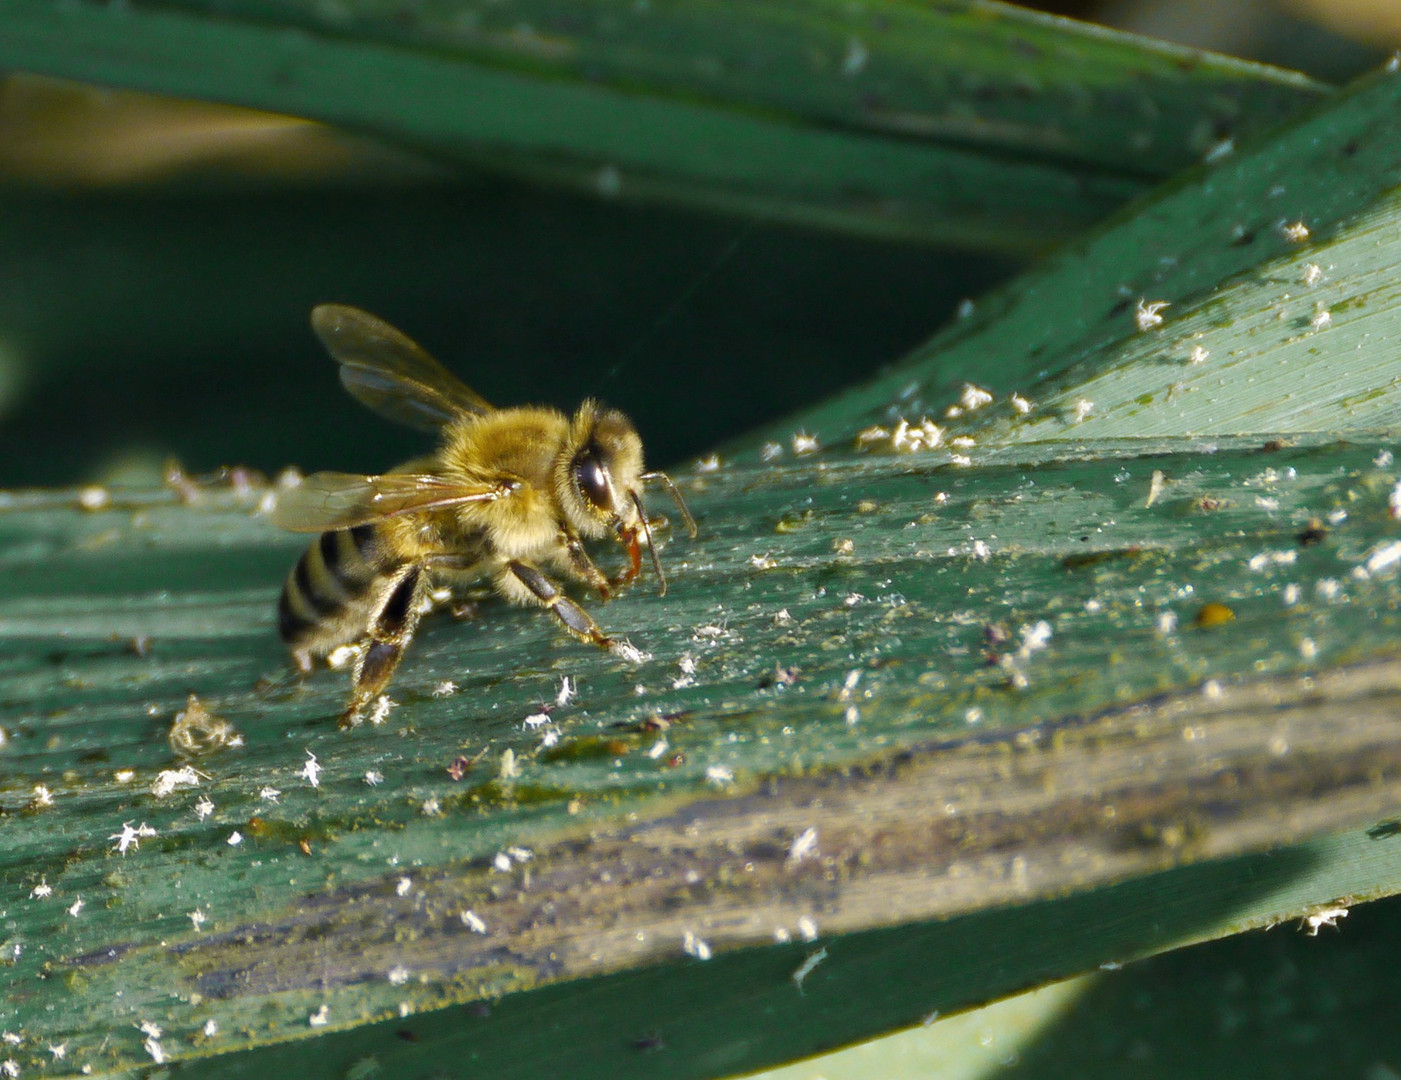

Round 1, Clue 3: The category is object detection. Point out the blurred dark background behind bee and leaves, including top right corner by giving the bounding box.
[0,0,1401,486]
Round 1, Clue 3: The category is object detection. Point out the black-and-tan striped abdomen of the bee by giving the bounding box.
[277,525,392,646]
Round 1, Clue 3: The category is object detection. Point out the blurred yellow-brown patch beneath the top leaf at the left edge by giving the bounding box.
[0,74,451,189]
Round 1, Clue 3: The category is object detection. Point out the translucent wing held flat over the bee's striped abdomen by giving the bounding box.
[270,472,516,532]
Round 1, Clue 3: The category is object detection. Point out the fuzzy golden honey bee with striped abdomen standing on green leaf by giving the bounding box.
[272,304,696,727]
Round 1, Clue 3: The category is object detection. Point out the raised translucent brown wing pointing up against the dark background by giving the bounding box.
[311,304,493,431]
